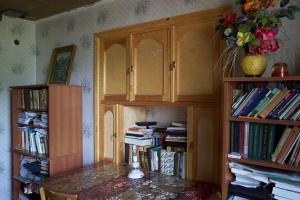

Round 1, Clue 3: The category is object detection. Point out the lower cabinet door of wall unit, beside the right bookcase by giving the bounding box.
[187,104,221,184]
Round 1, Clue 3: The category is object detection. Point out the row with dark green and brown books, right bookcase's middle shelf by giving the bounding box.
[229,122,300,166]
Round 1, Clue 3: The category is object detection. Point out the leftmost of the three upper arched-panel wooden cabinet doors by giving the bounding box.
[99,36,129,100]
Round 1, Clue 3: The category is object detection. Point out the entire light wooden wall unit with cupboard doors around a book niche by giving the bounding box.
[94,4,230,195]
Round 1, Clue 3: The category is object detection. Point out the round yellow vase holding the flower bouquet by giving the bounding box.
[241,55,268,76]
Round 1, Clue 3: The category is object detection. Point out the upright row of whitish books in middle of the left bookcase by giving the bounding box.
[18,126,48,155]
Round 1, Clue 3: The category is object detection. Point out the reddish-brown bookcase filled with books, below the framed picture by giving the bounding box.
[11,84,82,200]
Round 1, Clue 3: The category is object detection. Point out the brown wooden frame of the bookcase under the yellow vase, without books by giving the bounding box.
[222,76,300,200]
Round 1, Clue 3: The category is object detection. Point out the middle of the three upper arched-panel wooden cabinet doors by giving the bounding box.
[131,28,170,101]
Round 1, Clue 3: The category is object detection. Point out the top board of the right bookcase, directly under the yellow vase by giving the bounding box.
[223,76,300,82]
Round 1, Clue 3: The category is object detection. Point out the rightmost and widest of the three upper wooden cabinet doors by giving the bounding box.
[172,19,221,102]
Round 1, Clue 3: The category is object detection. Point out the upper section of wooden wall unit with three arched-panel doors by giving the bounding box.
[94,7,227,103]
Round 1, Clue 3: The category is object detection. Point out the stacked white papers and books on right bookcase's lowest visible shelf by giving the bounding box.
[228,162,300,200]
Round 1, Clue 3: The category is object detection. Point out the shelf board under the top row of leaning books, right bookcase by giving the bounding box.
[229,117,300,126]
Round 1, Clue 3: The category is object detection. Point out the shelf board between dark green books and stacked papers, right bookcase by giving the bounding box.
[228,158,300,172]
